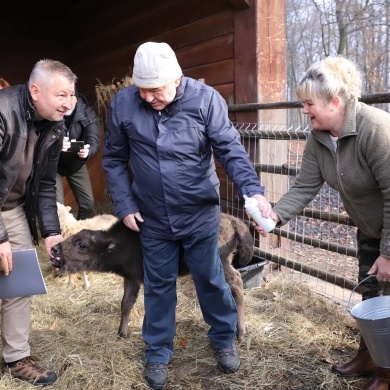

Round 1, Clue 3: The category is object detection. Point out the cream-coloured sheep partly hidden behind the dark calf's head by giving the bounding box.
[57,202,118,290]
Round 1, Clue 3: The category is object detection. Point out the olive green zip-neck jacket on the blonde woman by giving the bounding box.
[274,100,390,258]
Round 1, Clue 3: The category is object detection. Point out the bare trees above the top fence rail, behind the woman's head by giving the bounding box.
[286,0,390,104]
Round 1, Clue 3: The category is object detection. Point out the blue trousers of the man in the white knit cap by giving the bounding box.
[141,226,237,364]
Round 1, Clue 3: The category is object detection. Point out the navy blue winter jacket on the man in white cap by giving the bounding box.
[103,77,264,239]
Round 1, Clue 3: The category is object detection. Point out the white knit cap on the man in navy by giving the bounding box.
[132,42,182,88]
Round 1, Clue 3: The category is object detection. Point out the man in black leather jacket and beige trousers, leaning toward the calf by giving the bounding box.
[0,60,77,386]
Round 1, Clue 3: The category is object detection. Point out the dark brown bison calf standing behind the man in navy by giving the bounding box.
[50,214,253,340]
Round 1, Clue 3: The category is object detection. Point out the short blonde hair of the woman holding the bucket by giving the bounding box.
[296,56,362,103]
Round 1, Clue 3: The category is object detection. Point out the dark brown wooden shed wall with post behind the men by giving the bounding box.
[0,0,284,219]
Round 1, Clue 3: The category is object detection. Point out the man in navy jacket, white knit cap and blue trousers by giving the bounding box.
[103,42,272,390]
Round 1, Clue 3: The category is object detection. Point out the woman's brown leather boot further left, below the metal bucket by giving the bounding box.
[332,336,376,376]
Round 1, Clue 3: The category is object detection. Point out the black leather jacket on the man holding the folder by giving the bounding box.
[0,84,65,243]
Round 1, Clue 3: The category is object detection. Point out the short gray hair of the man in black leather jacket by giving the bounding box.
[28,59,77,87]
